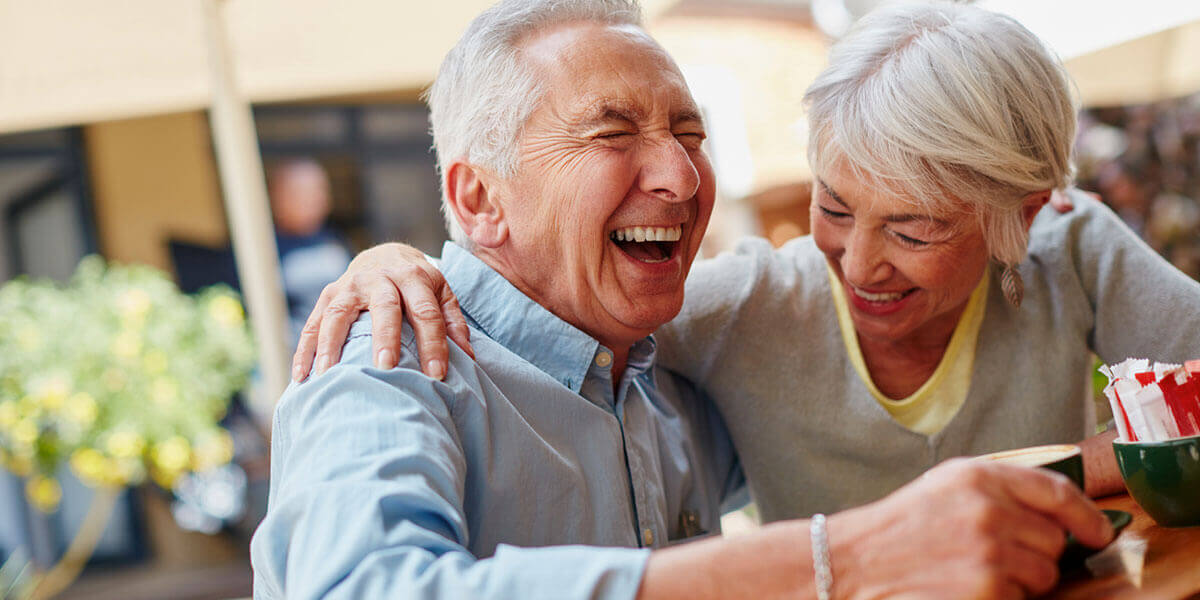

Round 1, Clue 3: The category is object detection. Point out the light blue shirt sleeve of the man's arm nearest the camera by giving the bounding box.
[251,325,649,600]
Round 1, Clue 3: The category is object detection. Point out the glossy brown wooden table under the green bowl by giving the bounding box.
[1046,494,1200,599]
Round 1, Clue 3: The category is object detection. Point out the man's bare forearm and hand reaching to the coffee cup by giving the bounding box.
[637,460,1112,600]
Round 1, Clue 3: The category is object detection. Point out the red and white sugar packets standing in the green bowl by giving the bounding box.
[1100,359,1200,442]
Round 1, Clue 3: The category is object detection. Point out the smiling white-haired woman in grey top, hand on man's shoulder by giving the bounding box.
[296,4,1200,520]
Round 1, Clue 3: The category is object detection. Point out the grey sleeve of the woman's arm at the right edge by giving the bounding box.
[1055,192,1200,364]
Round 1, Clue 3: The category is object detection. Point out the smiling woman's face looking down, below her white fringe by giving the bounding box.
[810,166,988,346]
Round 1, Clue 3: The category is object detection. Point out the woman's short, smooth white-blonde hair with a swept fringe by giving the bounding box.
[805,2,1076,265]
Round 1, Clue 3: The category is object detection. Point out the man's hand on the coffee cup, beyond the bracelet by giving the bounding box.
[829,458,1112,598]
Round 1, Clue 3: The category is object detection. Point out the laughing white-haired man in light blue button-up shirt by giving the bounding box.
[251,0,1111,599]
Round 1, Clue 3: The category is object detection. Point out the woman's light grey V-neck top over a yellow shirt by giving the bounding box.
[656,198,1200,521]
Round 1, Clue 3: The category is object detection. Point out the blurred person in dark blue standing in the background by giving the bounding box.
[266,158,350,342]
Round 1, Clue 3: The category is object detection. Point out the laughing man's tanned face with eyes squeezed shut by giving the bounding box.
[482,24,715,344]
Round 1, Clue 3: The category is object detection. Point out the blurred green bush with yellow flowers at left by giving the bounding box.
[0,257,254,511]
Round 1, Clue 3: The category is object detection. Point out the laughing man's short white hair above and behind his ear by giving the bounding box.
[426,0,642,247]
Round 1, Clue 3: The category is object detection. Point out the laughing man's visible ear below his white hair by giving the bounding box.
[446,161,509,248]
